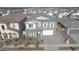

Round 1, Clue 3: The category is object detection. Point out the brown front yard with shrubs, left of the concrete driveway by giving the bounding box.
[0,37,43,48]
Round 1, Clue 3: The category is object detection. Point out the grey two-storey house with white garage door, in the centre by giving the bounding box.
[25,13,57,38]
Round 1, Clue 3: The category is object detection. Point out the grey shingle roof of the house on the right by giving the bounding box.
[59,18,79,28]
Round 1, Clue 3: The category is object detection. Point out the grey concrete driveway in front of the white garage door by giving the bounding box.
[43,33,64,45]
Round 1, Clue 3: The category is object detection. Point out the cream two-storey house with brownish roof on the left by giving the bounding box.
[0,13,27,39]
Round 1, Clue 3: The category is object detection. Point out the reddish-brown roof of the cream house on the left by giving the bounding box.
[0,13,30,23]
